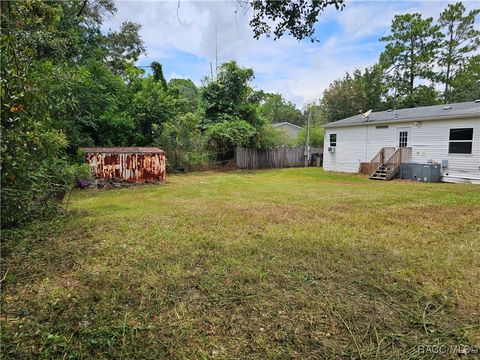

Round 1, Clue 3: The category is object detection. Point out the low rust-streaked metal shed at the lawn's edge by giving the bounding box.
[80,147,166,183]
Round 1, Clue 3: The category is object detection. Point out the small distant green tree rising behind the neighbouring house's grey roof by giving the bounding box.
[259,94,305,125]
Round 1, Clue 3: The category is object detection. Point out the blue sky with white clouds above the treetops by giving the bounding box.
[105,0,478,107]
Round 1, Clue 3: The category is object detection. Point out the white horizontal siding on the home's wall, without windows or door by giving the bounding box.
[323,119,480,180]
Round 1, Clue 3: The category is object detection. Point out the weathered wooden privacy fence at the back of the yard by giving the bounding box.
[235,146,323,169]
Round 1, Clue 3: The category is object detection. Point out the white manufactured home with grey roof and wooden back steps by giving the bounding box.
[323,100,480,183]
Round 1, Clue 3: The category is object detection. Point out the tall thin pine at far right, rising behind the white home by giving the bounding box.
[438,2,480,103]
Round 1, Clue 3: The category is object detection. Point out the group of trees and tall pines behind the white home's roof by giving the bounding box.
[321,2,480,121]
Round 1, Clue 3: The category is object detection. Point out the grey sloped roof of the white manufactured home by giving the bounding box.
[325,101,480,128]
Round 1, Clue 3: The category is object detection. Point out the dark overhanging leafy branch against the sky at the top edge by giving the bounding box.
[248,0,344,42]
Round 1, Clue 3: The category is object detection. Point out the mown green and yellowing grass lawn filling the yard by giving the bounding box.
[1,168,480,359]
